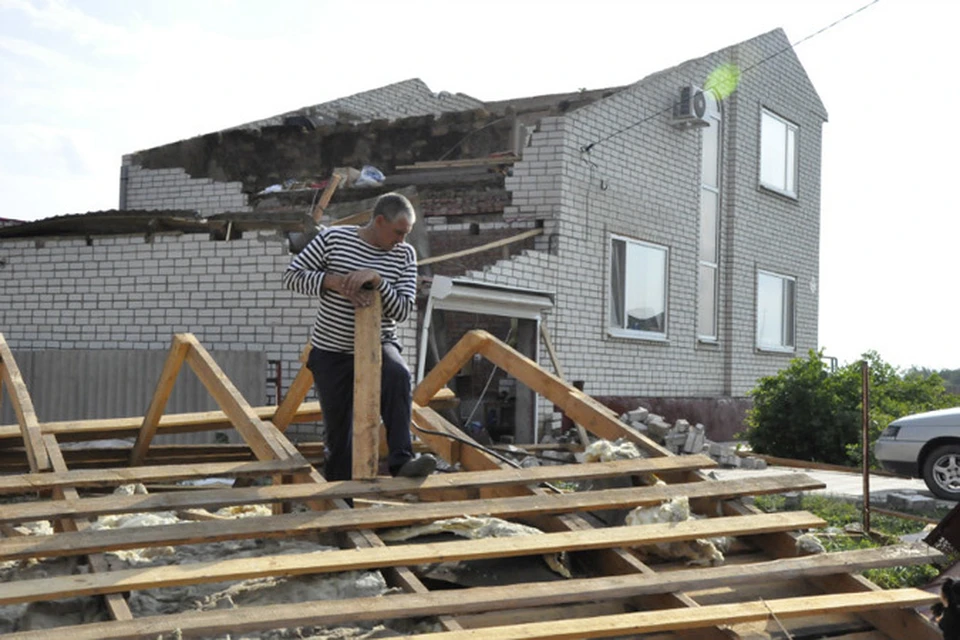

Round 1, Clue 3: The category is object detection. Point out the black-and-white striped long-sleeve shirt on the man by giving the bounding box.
[283,226,417,353]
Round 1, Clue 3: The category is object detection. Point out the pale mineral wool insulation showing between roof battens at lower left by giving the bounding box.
[0,485,439,640]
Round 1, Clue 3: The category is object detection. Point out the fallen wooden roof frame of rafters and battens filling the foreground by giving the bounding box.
[0,331,939,640]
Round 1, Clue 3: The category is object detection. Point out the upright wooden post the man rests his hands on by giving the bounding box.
[352,291,383,480]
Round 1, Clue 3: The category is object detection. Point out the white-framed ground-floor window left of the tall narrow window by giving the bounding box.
[610,236,669,340]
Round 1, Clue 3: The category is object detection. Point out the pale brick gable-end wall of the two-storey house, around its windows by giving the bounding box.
[462,31,825,397]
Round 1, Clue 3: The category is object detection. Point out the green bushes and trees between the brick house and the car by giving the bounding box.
[740,350,960,465]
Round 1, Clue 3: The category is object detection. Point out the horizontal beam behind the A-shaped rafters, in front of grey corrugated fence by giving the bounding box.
[0,401,323,442]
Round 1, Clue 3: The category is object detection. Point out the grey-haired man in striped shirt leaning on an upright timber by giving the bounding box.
[283,193,437,480]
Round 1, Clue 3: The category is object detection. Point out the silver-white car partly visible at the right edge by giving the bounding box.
[873,407,960,501]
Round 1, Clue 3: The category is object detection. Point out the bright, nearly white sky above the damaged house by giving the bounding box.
[0,0,960,369]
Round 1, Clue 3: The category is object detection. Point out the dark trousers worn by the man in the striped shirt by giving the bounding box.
[307,343,413,480]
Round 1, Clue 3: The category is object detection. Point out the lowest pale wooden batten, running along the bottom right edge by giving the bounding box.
[418,589,938,640]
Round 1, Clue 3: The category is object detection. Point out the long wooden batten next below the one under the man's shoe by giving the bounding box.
[0,474,823,561]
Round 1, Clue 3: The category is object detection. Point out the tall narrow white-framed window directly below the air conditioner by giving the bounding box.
[697,91,720,342]
